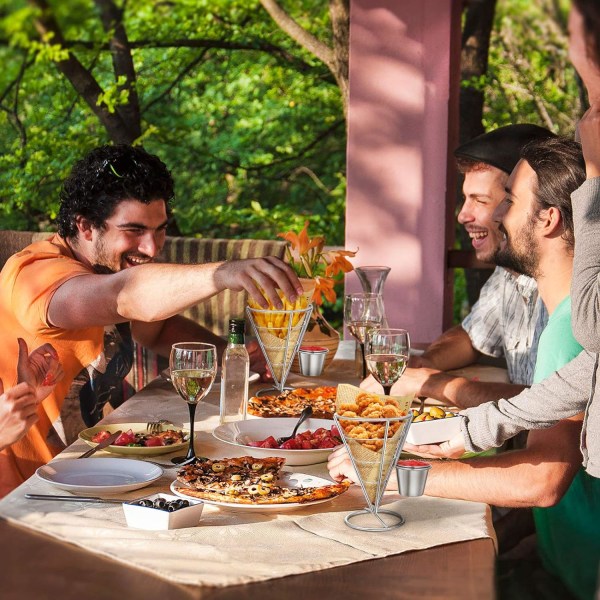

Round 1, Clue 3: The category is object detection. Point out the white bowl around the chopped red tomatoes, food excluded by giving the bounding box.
[213,417,341,467]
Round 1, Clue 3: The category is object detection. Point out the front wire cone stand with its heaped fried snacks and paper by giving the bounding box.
[333,384,413,531]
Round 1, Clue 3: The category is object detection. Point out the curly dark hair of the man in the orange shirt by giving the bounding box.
[56,144,174,239]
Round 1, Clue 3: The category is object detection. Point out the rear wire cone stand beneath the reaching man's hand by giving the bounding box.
[246,306,312,395]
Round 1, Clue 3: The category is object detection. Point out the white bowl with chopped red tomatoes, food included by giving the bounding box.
[213,417,342,466]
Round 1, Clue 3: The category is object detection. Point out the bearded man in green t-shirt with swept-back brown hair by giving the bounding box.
[329,138,600,598]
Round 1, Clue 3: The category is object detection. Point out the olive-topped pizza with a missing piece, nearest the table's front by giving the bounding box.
[177,456,350,504]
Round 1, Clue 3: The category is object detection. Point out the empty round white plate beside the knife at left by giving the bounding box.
[35,458,163,494]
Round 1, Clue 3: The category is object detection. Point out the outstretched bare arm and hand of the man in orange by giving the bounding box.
[48,256,302,329]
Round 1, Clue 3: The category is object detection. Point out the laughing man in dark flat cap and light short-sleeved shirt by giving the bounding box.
[362,124,555,408]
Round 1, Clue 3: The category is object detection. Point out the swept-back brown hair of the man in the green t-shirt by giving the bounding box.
[521,138,585,248]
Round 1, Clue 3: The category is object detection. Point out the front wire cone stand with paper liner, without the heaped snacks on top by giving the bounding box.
[333,384,412,531]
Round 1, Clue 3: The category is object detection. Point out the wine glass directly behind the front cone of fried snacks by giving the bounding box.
[365,329,410,396]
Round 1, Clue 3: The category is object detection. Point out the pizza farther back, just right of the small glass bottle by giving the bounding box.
[248,386,337,419]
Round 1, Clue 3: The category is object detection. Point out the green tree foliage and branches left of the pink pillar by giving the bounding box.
[0,0,345,244]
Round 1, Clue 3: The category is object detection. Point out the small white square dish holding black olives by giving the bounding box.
[123,494,204,531]
